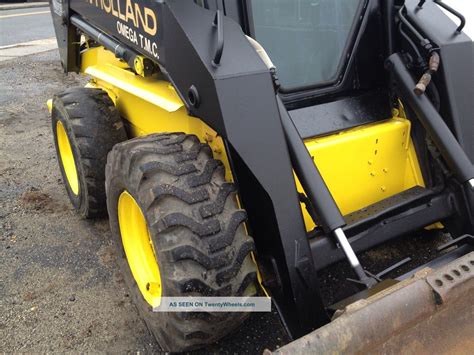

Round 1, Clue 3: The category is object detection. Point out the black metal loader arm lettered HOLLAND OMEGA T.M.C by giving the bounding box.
[62,0,334,337]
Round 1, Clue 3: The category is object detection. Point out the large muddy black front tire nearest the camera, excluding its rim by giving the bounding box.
[106,133,257,351]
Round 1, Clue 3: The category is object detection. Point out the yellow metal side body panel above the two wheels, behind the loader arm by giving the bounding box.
[82,47,233,181]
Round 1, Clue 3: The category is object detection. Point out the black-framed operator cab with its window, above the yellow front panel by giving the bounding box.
[196,0,391,139]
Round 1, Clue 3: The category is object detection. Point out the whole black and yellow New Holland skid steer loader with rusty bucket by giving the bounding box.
[49,0,474,353]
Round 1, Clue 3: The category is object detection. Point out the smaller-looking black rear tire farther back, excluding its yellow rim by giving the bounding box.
[51,88,127,218]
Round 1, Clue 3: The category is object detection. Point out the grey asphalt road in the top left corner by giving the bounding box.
[0,6,54,49]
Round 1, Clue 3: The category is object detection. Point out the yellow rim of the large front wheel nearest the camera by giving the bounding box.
[118,191,162,307]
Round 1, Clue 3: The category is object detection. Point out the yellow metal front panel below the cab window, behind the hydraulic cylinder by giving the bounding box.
[297,118,424,229]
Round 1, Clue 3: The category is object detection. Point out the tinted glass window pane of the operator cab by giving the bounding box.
[251,0,361,89]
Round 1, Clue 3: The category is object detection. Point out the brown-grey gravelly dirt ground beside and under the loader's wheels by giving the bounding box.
[0,51,288,353]
